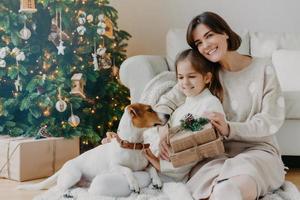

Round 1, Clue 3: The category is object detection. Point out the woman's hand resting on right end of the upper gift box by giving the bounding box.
[205,112,230,137]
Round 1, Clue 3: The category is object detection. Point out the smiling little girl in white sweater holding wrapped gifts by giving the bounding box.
[144,49,224,181]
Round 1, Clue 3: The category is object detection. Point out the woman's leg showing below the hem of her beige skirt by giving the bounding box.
[210,175,257,200]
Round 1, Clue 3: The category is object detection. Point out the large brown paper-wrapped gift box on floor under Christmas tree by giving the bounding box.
[0,136,79,181]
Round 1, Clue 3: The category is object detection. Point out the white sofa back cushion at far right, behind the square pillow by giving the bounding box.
[249,32,300,57]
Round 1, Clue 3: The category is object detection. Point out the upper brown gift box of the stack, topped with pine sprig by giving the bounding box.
[169,123,217,153]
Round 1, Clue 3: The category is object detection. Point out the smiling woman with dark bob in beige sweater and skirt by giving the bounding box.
[157,12,285,200]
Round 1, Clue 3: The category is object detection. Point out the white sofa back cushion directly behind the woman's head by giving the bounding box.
[166,29,250,71]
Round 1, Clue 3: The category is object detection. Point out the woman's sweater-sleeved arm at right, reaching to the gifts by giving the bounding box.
[214,64,285,141]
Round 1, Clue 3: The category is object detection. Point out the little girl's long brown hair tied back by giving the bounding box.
[175,49,223,102]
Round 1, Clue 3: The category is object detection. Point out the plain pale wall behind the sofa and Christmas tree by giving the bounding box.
[111,0,300,56]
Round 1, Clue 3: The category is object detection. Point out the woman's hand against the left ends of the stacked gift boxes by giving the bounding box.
[158,125,170,161]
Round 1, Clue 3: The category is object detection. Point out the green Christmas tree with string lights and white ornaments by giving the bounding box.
[0,0,130,148]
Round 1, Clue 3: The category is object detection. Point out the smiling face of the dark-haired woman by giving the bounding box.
[193,24,228,62]
